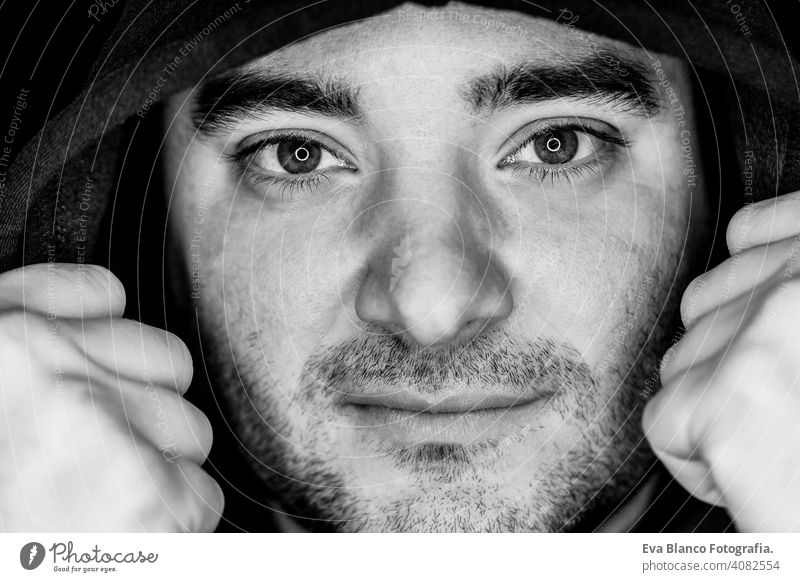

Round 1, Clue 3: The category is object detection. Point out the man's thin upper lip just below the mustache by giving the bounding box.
[342,390,542,413]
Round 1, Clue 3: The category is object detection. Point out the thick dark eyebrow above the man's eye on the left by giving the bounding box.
[192,71,361,134]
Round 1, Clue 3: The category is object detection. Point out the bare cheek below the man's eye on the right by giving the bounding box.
[515,176,688,363]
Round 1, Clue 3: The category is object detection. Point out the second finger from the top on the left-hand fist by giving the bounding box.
[58,319,193,394]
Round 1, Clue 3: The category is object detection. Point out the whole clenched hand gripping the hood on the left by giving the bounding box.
[0,263,223,532]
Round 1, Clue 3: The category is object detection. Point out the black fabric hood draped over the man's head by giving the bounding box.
[0,0,800,270]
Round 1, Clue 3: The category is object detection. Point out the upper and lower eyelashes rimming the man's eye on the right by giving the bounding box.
[498,121,631,184]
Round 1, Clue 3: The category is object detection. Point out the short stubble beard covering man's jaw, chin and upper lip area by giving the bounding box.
[206,302,675,532]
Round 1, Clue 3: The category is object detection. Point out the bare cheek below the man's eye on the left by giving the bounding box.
[192,197,342,371]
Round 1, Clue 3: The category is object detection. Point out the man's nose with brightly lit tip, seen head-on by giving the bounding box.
[356,176,513,347]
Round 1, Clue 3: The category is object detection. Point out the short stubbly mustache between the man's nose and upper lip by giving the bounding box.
[301,331,596,394]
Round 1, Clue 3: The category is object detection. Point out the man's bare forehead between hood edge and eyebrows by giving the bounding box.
[241,3,672,97]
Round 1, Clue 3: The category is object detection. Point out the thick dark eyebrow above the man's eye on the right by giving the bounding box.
[464,55,662,117]
